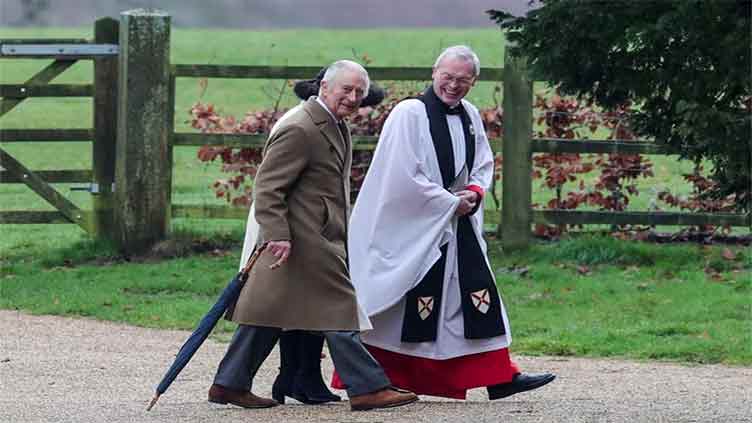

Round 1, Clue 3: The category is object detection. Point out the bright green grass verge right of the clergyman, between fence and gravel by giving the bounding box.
[494,237,752,365]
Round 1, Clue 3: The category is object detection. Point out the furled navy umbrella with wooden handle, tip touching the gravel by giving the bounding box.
[146,244,266,411]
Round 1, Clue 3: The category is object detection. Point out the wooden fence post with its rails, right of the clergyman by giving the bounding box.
[499,56,752,249]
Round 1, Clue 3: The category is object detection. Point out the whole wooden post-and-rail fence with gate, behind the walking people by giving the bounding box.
[0,10,752,252]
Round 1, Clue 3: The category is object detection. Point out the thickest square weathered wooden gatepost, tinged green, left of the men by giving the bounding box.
[115,9,172,253]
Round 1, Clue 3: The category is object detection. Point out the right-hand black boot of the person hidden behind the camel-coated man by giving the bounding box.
[292,332,342,404]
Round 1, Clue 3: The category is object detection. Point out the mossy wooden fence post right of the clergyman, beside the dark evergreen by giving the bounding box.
[499,45,533,250]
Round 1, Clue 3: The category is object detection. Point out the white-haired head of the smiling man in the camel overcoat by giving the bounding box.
[320,69,366,120]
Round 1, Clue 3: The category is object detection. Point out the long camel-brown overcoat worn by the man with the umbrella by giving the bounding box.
[228,98,370,331]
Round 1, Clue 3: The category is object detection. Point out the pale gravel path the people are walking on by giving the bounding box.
[0,311,752,423]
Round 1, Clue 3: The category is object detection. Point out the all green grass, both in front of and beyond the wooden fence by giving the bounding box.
[0,28,752,365]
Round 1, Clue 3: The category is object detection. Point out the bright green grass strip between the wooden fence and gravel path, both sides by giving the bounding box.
[0,232,752,365]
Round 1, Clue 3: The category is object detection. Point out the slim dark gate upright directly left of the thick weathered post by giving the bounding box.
[92,18,119,240]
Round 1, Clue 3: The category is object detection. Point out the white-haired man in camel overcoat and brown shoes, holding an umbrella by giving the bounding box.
[209,60,417,410]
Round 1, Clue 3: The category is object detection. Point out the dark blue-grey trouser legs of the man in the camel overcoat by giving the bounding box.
[214,325,391,397]
